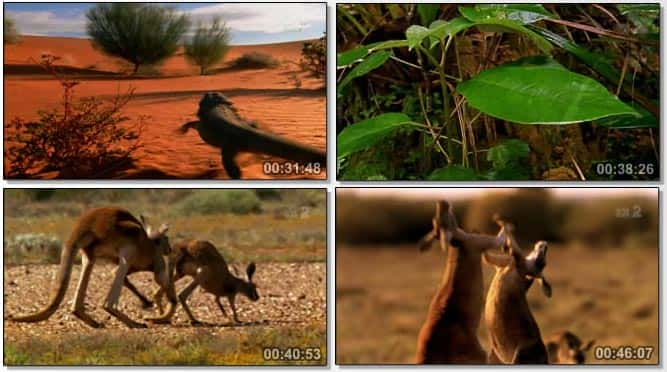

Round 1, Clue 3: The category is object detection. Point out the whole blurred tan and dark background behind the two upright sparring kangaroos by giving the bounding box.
[336,188,659,364]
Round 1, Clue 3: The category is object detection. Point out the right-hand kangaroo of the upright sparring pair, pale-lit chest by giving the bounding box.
[484,219,551,364]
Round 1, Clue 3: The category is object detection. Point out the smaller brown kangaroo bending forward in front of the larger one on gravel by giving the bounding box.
[154,240,259,324]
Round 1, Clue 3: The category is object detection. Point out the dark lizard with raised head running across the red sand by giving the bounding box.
[179,92,327,179]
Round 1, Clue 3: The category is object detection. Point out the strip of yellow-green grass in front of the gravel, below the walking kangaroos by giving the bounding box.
[4,326,326,366]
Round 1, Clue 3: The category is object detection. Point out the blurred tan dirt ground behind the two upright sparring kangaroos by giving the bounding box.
[335,245,660,364]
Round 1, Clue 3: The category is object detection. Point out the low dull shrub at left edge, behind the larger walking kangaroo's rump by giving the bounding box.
[4,234,62,264]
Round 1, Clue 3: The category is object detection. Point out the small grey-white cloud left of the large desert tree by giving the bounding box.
[7,11,86,35]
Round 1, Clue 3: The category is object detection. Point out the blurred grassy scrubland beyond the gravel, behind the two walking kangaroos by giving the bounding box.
[3,189,327,265]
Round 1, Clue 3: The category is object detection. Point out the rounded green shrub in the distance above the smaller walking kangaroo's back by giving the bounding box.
[174,189,262,215]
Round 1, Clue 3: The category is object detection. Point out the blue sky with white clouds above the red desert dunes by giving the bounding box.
[4,3,326,45]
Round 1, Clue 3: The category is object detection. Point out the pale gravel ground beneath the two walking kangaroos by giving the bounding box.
[3,263,326,341]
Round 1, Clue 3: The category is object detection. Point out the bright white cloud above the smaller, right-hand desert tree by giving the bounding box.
[188,3,326,34]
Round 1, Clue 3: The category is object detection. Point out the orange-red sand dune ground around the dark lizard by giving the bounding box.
[4,36,326,179]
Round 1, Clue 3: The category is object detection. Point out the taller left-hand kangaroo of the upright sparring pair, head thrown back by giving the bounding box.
[416,201,506,364]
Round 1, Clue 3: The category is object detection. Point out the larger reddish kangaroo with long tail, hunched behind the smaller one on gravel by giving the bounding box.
[11,207,176,328]
